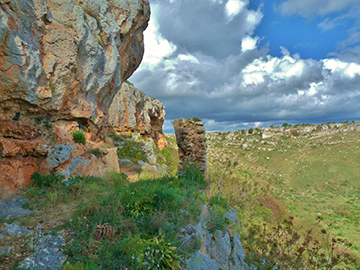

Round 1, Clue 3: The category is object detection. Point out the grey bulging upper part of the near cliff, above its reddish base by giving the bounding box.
[0,0,150,121]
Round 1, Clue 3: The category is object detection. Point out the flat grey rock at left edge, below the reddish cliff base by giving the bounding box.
[0,196,35,219]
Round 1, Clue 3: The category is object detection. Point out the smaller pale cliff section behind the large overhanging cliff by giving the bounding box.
[109,81,166,149]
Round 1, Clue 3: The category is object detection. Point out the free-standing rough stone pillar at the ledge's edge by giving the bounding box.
[172,119,207,179]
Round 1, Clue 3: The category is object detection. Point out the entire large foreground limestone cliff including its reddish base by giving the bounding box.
[0,0,150,189]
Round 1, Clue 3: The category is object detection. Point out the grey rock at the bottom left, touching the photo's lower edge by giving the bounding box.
[17,235,66,270]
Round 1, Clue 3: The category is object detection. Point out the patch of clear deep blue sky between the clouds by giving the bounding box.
[250,0,348,60]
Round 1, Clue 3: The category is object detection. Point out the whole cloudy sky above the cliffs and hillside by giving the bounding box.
[129,0,360,133]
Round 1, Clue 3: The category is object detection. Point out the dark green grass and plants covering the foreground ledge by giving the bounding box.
[0,168,208,269]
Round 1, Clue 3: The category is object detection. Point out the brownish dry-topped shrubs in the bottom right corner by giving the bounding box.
[243,217,351,270]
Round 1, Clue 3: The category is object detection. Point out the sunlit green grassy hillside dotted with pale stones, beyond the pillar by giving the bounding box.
[207,123,360,269]
